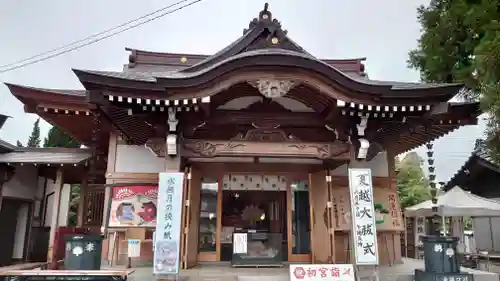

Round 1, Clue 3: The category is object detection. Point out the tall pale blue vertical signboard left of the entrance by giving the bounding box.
[153,173,184,275]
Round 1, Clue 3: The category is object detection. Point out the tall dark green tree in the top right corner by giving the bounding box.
[408,0,500,160]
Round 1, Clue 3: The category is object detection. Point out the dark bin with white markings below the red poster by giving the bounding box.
[64,234,103,270]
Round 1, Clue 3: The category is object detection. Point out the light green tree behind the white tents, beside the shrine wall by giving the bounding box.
[396,152,431,209]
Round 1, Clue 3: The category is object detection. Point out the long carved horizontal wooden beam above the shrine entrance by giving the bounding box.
[181,139,349,160]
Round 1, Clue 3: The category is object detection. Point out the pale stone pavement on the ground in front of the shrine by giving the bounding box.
[122,259,500,281]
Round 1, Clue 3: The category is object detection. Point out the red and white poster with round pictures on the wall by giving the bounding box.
[109,185,158,227]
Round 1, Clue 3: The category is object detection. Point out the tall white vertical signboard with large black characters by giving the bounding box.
[349,169,378,265]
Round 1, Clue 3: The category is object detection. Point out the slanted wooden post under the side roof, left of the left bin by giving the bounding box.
[47,168,64,269]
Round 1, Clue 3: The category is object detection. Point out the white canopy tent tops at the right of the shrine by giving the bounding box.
[405,186,500,217]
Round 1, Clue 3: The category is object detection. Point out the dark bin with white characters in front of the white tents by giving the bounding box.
[420,235,460,273]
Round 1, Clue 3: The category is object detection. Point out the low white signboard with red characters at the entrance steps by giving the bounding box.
[290,264,354,281]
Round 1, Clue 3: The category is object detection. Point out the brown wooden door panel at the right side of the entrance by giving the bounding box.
[309,170,335,263]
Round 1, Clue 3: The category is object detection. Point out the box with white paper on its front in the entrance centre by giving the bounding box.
[231,229,283,266]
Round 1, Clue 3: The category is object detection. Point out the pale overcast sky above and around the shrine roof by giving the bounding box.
[0,0,484,180]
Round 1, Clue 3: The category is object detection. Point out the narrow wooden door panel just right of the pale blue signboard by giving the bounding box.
[181,167,201,269]
